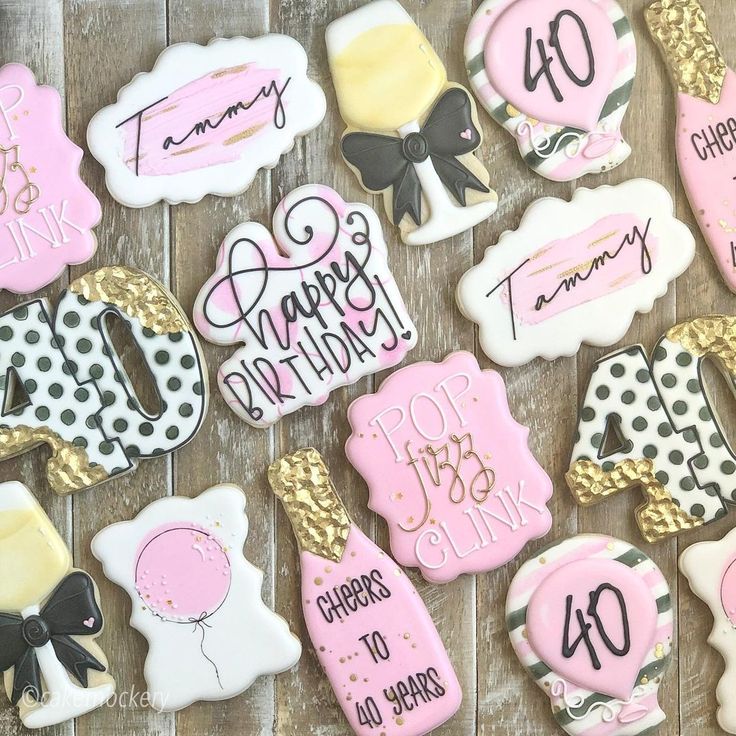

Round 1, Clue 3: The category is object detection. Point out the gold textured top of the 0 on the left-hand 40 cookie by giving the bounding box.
[69,266,191,335]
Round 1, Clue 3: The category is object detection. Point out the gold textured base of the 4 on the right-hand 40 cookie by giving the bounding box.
[565,458,703,542]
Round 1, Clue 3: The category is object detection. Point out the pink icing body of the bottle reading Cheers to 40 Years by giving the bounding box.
[301,524,462,736]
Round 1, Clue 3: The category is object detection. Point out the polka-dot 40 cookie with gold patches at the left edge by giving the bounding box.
[0,266,207,494]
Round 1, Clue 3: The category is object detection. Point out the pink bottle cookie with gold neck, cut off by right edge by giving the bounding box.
[646,0,736,292]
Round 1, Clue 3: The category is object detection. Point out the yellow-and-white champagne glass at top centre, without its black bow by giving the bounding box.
[326,0,497,245]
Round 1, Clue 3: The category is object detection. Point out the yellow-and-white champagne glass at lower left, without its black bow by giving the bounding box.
[0,482,115,728]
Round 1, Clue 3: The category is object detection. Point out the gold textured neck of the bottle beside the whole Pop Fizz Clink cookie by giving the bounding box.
[268,447,351,562]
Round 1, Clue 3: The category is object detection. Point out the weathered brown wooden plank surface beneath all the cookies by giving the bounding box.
[0,0,736,736]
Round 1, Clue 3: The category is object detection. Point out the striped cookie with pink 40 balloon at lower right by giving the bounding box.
[506,534,673,736]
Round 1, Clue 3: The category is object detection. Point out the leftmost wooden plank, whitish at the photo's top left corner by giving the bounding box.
[0,0,70,736]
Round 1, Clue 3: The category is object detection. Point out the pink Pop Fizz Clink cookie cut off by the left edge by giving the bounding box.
[0,64,101,294]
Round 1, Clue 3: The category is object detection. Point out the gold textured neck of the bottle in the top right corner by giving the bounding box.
[646,0,728,104]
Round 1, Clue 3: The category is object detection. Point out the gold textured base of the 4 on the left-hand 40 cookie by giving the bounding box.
[0,424,108,496]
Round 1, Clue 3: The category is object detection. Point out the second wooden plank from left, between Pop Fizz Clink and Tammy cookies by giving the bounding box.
[64,0,174,736]
